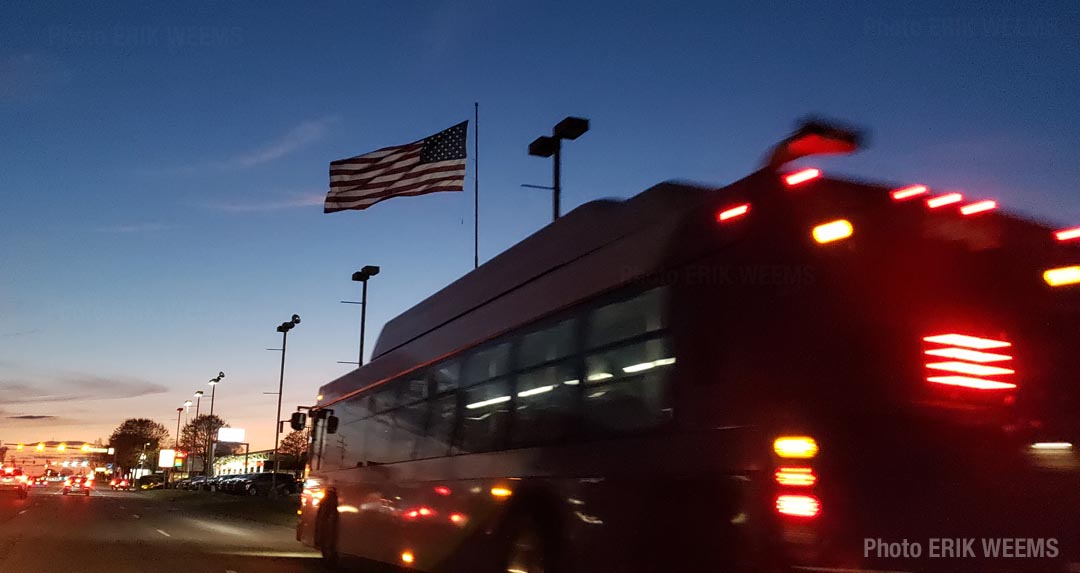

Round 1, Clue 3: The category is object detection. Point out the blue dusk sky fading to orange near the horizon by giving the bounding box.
[0,0,1080,448]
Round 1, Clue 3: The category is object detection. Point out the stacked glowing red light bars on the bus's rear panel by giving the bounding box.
[922,332,1016,390]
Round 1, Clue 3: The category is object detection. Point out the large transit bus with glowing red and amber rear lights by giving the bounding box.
[297,125,1080,573]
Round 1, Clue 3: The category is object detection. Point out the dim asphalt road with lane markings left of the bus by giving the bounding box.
[0,486,324,573]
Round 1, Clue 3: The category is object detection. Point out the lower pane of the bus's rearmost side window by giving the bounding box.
[584,338,675,434]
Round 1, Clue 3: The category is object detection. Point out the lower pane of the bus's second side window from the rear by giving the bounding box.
[511,360,580,446]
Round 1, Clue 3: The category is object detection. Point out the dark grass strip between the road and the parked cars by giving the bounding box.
[139,490,300,527]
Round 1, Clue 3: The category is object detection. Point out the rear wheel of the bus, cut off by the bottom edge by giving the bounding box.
[496,508,563,573]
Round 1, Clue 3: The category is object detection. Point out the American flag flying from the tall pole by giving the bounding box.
[323,121,469,213]
